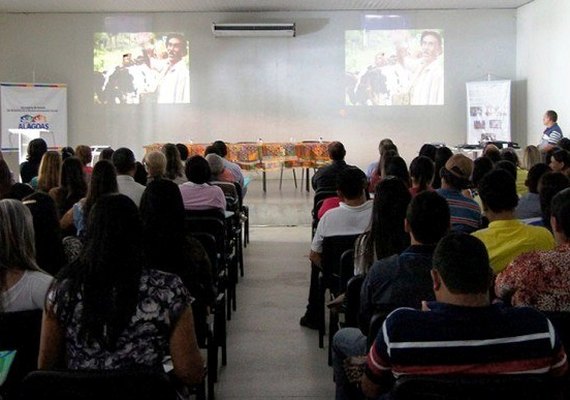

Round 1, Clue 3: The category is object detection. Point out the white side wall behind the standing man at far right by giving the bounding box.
[517,0,570,148]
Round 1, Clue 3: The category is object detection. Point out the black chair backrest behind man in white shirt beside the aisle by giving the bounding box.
[321,235,359,294]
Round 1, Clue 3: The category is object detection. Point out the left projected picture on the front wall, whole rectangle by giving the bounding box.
[93,32,190,104]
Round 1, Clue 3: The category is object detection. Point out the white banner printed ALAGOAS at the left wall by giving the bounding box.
[0,83,67,152]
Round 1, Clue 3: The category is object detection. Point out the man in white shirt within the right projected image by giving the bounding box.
[410,31,443,105]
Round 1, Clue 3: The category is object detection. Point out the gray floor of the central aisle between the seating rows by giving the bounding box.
[216,227,334,400]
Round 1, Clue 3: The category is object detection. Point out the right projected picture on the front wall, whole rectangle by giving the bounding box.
[345,29,444,106]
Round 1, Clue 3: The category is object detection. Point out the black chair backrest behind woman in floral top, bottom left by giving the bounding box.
[22,370,176,400]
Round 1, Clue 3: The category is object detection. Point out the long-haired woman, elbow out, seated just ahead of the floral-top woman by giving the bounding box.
[59,160,119,238]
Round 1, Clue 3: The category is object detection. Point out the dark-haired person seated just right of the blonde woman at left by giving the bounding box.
[22,192,65,276]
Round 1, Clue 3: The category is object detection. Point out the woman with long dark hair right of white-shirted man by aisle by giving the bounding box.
[354,178,412,275]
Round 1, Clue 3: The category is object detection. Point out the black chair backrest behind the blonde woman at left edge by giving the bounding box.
[0,310,42,392]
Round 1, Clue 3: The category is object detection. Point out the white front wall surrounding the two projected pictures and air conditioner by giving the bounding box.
[0,9,516,167]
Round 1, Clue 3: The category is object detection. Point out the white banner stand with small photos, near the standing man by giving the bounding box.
[466,80,511,144]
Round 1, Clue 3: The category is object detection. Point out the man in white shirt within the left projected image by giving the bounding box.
[158,33,190,103]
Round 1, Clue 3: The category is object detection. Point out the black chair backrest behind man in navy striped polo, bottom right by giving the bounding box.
[390,374,561,400]
